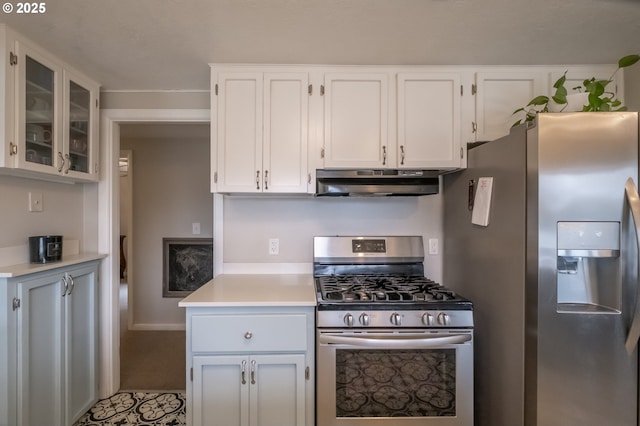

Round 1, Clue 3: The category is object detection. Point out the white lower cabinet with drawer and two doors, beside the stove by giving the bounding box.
[187,307,315,426]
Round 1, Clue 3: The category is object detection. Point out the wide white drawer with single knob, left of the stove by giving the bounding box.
[191,314,307,352]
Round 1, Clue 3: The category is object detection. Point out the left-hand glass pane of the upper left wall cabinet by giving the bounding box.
[23,56,56,166]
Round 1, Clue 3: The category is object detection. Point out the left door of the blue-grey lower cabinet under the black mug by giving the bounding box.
[16,275,66,426]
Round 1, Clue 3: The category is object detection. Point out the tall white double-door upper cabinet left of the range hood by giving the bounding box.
[212,70,309,193]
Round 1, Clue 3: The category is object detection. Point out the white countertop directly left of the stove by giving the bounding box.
[178,274,316,308]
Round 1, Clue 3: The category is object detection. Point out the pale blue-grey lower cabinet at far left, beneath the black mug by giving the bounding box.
[0,262,98,426]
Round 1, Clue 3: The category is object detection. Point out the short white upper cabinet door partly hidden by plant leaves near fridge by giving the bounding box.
[476,70,547,141]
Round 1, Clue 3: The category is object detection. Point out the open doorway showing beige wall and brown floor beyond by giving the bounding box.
[119,123,213,391]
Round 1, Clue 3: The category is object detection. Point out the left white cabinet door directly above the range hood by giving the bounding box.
[324,73,388,168]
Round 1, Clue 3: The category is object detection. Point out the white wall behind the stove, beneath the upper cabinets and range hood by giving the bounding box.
[223,195,442,281]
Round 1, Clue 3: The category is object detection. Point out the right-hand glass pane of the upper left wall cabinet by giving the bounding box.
[65,80,91,173]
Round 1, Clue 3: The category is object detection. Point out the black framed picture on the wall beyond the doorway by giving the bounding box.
[162,238,213,297]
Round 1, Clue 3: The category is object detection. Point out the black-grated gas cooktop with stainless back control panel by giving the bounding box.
[314,236,472,311]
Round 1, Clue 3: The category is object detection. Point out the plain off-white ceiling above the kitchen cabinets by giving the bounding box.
[0,0,640,90]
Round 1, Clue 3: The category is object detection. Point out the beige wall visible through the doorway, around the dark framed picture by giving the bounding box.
[120,125,213,329]
